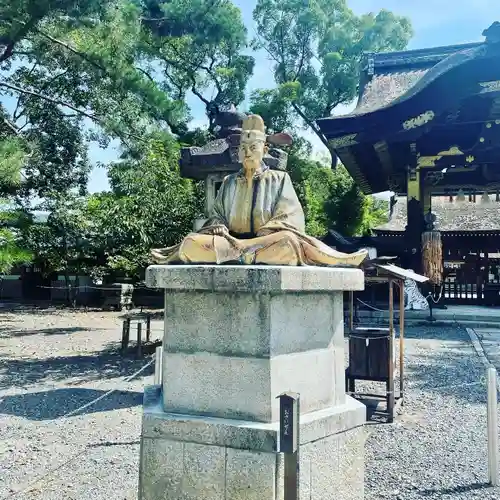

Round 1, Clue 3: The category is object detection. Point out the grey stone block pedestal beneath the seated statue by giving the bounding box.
[139,266,366,500]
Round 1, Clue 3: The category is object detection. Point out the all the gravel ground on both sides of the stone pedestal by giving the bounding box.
[0,310,500,500]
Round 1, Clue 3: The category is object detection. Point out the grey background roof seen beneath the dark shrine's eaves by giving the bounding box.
[377,196,500,231]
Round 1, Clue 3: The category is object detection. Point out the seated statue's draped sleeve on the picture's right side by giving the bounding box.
[258,173,305,236]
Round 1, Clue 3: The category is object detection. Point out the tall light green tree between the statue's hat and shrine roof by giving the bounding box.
[254,0,412,160]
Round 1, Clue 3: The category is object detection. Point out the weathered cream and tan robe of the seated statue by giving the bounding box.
[152,167,367,266]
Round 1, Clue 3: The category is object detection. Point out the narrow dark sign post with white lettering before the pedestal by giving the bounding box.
[278,392,300,500]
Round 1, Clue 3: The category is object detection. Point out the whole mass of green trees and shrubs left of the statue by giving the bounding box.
[0,0,253,275]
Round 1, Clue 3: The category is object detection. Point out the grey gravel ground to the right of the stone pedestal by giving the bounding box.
[360,326,500,500]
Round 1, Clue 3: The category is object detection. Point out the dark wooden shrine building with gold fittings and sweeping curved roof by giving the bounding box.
[317,22,500,304]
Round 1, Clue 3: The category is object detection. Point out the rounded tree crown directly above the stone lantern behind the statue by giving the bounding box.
[144,0,254,135]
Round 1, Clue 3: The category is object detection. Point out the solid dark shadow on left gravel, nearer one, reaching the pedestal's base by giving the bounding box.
[0,388,143,421]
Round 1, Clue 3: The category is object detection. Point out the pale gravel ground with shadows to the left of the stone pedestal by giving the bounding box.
[0,304,161,500]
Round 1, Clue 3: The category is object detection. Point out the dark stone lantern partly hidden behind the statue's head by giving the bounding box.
[180,106,288,231]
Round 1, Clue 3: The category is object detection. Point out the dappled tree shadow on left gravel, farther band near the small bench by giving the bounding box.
[0,344,154,389]
